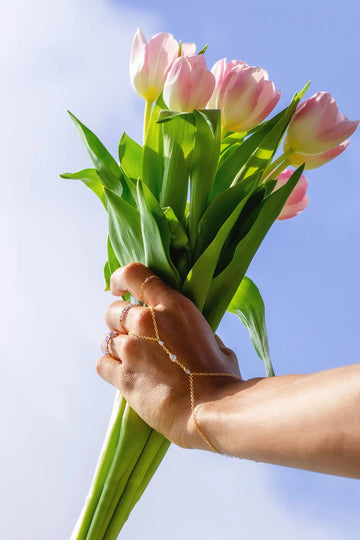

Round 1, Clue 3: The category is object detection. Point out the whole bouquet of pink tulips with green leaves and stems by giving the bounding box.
[62,29,357,540]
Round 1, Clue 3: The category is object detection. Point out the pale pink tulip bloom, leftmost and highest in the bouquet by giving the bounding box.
[130,28,179,101]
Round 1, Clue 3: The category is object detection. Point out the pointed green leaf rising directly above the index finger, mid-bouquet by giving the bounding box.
[137,179,179,288]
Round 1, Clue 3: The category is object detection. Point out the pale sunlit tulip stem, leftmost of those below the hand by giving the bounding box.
[71,392,126,540]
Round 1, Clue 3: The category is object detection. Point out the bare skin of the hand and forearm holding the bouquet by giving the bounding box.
[96,263,360,478]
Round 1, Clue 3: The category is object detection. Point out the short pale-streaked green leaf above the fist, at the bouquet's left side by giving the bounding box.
[105,189,146,266]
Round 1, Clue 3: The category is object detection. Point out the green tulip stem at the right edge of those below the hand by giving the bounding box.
[104,430,170,540]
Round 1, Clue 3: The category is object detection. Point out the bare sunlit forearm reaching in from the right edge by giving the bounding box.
[193,364,360,478]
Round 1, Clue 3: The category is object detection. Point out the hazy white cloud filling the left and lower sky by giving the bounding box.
[0,0,354,540]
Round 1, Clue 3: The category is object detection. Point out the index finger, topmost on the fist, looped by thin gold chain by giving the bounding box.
[110,262,179,307]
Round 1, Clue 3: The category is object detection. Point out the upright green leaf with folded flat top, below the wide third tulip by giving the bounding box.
[189,109,221,247]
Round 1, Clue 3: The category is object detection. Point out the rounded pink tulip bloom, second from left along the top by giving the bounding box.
[164,54,215,112]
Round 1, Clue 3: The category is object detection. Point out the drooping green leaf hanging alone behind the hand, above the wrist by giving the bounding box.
[227,276,275,377]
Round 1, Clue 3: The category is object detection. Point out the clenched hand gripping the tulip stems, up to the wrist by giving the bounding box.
[97,263,241,449]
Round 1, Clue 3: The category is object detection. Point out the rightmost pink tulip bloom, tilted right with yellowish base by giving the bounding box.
[284,92,359,155]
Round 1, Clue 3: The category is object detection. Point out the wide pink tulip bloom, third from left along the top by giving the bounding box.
[209,59,280,132]
